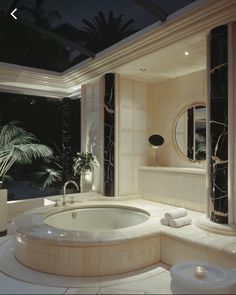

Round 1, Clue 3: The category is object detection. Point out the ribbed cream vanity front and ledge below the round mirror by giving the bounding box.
[139,166,207,212]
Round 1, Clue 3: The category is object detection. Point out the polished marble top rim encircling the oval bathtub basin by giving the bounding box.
[13,204,153,246]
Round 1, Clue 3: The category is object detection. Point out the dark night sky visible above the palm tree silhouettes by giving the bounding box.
[0,0,194,28]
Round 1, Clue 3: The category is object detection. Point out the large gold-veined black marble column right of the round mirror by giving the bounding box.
[209,25,228,223]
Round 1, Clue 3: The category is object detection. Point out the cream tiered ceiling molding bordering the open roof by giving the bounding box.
[0,0,236,97]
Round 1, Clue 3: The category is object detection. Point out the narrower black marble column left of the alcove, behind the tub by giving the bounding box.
[103,73,115,196]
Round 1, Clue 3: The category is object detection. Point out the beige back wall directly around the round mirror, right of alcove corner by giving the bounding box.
[147,70,207,167]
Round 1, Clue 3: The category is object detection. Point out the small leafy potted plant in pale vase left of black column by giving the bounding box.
[73,152,96,192]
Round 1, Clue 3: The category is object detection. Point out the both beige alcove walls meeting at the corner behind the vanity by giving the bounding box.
[116,70,206,195]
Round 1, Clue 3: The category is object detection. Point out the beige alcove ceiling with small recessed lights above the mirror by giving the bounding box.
[115,33,206,83]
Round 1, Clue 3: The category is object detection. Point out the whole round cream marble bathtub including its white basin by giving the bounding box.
[13,202,160,276]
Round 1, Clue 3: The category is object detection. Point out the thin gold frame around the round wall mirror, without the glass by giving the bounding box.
[172,101,207,163]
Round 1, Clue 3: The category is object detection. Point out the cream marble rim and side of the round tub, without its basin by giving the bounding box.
[13,201,160,276]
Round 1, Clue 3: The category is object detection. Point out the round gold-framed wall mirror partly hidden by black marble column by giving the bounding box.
[173,103,206,161]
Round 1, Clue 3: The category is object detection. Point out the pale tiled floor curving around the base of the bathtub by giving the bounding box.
[0,231,172,294]
